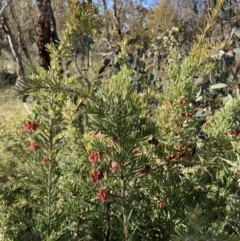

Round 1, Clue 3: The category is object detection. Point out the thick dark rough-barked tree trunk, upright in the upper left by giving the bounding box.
[35,0,59,70]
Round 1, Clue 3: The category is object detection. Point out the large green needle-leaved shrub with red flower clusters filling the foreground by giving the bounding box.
[0,1,240,241]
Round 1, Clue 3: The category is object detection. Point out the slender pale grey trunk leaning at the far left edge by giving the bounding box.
[0,0,26,81]
